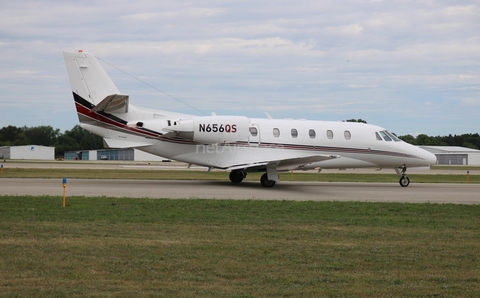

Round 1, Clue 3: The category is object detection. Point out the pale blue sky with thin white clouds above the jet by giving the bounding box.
[0,0,480,136]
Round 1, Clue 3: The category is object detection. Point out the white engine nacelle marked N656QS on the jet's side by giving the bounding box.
[163,116,250,144]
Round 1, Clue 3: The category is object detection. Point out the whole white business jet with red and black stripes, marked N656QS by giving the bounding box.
[64,51,437,187]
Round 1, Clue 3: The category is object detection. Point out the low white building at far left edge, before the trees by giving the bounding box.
[0,145,55,160]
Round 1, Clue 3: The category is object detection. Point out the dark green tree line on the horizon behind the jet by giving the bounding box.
[0,123,480,156]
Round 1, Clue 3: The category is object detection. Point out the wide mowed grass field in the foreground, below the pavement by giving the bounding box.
[0,196,480,297]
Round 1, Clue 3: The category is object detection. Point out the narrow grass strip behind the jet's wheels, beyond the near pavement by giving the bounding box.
[2,168,480,183]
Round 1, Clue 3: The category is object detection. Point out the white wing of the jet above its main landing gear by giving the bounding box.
[226,154,340,172]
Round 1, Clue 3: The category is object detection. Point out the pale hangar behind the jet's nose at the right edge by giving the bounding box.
[419,146,480,166]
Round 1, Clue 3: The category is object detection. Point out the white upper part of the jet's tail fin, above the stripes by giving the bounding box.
[63,51,120,105]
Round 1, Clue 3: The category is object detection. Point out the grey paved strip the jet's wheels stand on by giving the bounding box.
[0,178,480,204]
